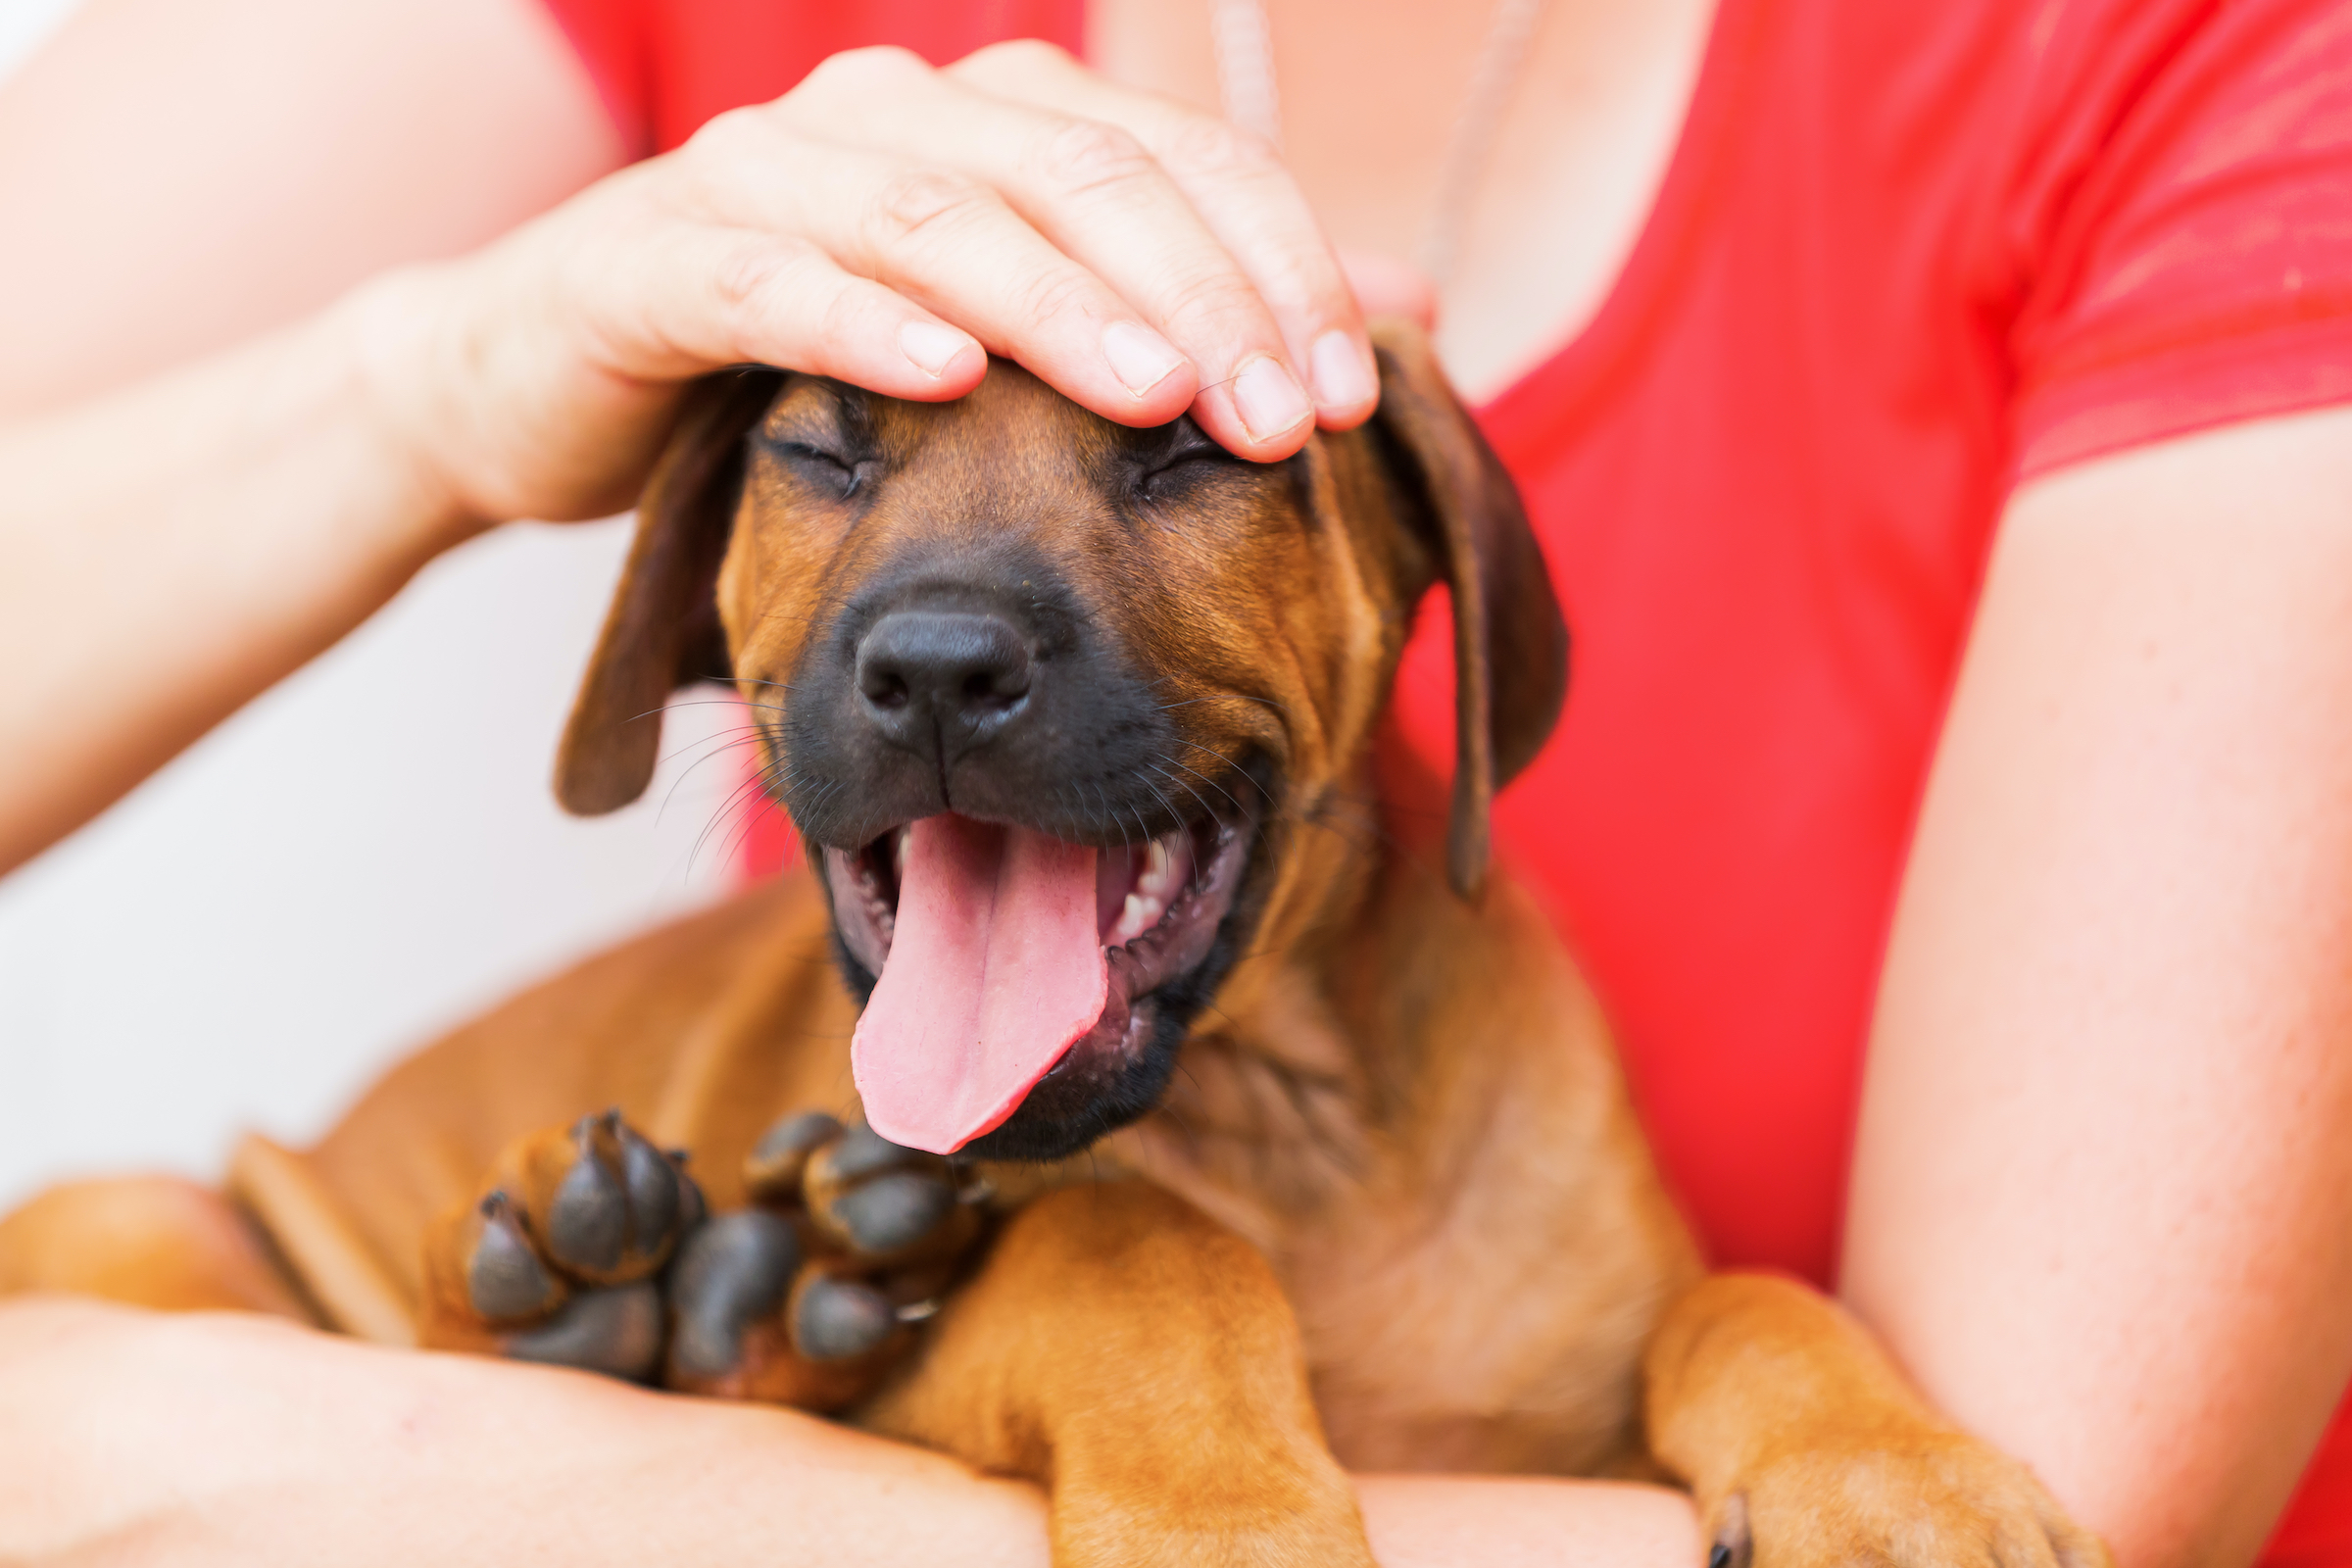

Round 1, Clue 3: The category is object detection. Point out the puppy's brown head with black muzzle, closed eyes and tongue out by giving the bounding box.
[558,326,1566,1159]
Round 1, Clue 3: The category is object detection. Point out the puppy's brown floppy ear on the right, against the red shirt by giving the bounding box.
[1371,319,1569,898]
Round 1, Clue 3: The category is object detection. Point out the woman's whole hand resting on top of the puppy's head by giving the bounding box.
[355,42,1378,522]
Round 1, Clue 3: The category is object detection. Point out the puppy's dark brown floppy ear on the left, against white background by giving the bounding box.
[555,369,783,815]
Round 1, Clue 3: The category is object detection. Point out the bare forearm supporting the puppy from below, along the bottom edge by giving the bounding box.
[0,1298,1695,1568]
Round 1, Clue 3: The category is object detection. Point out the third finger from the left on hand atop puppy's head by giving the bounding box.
[778,49,1315,459]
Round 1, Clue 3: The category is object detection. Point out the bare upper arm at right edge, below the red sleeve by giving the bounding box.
[1844,412,2352,1568]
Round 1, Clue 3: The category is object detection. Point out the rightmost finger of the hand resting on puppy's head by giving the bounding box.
[948,40,1378,430]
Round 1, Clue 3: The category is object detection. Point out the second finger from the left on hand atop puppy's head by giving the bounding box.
[689,111,1198,425]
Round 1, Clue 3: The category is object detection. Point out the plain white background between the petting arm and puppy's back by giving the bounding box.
[0,0,741,1208]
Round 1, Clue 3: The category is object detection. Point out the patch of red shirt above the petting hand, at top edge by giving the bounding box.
[548,0,1084,155]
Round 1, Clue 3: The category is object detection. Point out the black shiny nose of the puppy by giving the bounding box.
[858,609,1035,750]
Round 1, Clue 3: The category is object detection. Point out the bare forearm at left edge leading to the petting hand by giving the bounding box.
[0,303,472,872]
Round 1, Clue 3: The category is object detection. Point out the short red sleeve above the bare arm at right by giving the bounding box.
[2004,0,2352,477]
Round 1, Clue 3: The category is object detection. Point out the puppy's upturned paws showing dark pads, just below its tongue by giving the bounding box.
[423,1112,986,1410]
